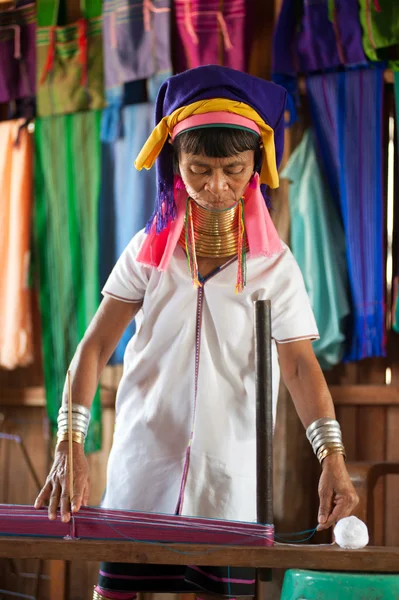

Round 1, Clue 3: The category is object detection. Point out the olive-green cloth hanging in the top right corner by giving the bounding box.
[359,0,399,69]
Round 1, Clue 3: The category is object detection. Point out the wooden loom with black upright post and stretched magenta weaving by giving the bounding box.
[0,301,399,578]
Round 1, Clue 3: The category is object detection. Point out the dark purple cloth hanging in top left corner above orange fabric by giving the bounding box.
[0,4,36,102]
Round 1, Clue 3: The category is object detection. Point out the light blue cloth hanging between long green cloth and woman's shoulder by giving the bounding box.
[99,81,158,364]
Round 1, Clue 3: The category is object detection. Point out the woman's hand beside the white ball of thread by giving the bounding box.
[317,454,359,531]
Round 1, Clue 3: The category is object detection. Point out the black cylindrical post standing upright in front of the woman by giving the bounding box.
[254,300,274,525]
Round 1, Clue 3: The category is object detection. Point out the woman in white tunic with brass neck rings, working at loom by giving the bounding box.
[36,66,356,599]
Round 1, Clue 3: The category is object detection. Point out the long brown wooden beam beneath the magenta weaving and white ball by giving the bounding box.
[0,537,399,573]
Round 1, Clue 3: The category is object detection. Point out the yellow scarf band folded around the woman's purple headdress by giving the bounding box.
[134,98,279,188]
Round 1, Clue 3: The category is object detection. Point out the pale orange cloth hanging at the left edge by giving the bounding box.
[0,120,33,369]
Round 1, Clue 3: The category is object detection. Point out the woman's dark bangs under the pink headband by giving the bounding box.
[173,127,260,162]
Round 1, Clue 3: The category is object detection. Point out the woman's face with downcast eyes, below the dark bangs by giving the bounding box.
[179,150,255,210]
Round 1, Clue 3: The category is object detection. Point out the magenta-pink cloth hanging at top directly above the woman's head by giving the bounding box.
[175,0,253,73]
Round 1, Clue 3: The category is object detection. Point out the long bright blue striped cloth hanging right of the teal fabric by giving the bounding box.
[307,69,386,361]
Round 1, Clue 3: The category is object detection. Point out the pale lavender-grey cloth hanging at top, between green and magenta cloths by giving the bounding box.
[103,0,172,89]
